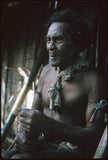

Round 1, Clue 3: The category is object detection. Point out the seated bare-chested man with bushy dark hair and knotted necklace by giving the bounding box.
[2,9,105,159]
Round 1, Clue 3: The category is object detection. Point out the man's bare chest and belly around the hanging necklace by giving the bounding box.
[41,70,87,125]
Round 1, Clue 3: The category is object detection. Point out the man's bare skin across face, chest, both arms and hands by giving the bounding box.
[13,23,105,155]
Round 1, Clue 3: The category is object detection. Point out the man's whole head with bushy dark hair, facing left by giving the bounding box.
[46,9,91,67]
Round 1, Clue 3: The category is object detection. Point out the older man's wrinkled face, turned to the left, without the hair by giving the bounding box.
[46,22,72,67]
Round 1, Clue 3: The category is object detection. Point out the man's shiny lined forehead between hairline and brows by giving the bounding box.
[47,22,68,35]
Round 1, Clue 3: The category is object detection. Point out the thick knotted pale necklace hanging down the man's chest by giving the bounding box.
[48,57,89,111]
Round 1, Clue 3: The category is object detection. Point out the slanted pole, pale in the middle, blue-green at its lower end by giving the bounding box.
[1,47,43,143]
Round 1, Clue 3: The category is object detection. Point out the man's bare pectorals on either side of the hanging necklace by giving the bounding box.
[42,75,85,110]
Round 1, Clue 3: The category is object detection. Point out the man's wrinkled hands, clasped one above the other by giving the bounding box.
[15,109,43,153]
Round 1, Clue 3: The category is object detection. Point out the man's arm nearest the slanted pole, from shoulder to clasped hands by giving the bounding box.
[15,64,47,152]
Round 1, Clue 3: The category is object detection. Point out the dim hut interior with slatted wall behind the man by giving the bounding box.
[1,1,108,158]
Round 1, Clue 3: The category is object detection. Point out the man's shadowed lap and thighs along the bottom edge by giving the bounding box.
[2,149,81,159]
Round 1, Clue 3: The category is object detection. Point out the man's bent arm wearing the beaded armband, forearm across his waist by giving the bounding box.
[38,72,105,145]
